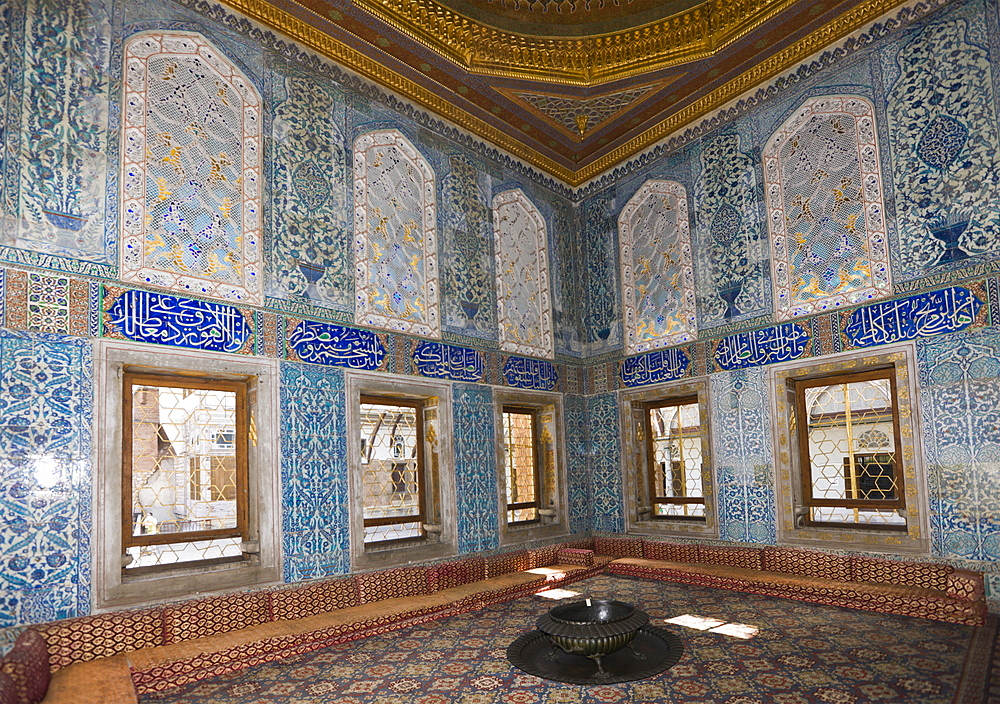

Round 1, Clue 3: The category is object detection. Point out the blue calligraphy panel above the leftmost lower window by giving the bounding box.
[107,291,251,352]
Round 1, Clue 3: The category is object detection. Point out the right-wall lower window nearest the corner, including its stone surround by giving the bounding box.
[622,379,718,538]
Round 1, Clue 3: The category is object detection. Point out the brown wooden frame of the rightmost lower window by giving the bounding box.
[789,367,906,530]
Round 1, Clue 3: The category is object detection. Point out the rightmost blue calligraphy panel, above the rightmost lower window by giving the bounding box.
[844,286,983,347]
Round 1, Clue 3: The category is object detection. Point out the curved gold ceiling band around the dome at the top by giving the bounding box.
[355,0,798,87]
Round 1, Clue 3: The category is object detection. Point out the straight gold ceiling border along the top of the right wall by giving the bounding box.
[569,0,911,188]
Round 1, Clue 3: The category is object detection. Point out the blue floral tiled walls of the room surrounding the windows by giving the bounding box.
[0,0,1000,642]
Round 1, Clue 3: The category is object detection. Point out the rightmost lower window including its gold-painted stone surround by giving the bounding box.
[771,344,930,552]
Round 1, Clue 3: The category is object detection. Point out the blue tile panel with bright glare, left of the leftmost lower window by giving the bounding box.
[0,331,93,627]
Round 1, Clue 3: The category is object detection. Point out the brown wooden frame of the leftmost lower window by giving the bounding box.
[121,370,250,550]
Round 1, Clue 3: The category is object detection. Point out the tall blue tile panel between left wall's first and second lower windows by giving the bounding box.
[281,362,351,582]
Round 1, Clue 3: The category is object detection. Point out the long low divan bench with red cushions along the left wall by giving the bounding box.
[0,544,610,704]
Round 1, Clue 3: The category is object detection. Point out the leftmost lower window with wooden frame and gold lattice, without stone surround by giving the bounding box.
[122,371,249,570]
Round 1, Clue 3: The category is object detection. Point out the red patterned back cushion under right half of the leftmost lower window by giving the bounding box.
[163,592,270,644]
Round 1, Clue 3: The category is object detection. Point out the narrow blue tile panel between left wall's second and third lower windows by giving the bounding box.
[453,384,500,553]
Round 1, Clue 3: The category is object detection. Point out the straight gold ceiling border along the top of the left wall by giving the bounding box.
[219,0,575,184]
